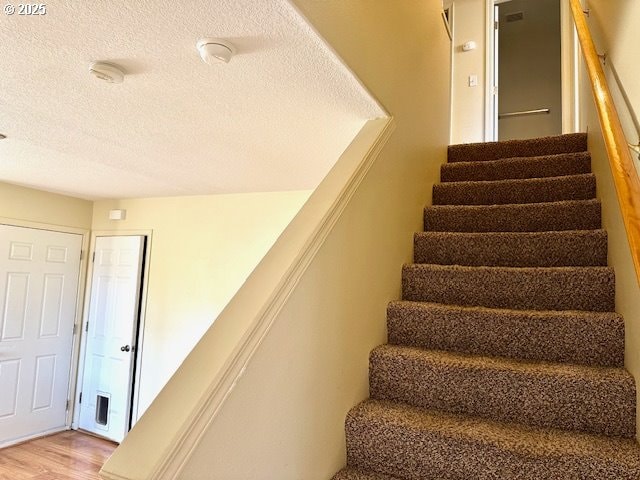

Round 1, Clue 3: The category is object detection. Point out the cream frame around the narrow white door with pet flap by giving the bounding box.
[71,230,153,429]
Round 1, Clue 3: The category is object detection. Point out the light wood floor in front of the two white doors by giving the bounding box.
[0,430,117,480]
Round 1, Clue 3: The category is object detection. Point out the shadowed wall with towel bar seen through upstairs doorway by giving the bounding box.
[498,0,562,140]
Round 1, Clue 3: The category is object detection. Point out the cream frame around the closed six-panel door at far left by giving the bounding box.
[0,217,90,441]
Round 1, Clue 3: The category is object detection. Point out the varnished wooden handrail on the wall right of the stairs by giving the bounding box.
[570,0,640,284]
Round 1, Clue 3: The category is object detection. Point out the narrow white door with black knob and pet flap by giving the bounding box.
[79,236,144,442]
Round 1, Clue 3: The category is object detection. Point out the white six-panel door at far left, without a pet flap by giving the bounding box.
[0,225,82,446]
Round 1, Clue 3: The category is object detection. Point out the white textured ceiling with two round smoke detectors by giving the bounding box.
[0,0,385,199]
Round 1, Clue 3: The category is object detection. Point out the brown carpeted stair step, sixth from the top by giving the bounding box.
[402,264,615,312]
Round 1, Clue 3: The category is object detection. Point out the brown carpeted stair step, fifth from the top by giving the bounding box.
[413,230,607,267]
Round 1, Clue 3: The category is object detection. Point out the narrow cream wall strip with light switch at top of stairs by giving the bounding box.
[451,0,486,143]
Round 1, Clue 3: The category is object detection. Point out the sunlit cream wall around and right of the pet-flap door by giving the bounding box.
[93,191,310,414]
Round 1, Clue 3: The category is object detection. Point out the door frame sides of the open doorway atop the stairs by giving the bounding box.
[484,0,580,142]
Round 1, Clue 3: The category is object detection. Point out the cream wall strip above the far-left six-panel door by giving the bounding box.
[0,182,92,230]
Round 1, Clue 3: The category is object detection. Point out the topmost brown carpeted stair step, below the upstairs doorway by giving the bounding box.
[447,133,587,162]
